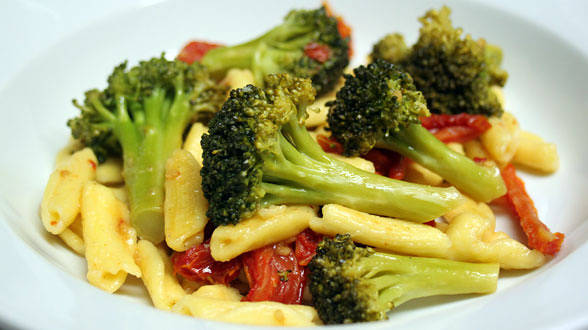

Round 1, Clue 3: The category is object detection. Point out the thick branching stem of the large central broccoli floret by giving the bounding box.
[262,123,462,222]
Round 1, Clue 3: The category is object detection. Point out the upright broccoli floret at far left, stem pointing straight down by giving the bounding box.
[67,55,227,243]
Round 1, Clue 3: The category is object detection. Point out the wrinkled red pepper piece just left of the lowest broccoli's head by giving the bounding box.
[241,243,306,304]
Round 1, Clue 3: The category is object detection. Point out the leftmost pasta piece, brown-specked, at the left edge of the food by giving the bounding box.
[41,148,98,235]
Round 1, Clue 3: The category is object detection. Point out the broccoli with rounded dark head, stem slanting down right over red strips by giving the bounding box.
[327,60,506,202]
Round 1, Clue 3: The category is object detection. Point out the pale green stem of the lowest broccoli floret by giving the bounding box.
[366,252,500,310]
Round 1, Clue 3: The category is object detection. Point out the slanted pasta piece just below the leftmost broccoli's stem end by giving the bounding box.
[135,240,186,310]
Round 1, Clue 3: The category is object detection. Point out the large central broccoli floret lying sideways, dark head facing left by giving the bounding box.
[201,74,462,226]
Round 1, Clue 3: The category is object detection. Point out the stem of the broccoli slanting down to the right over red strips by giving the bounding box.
[376,124,506,202]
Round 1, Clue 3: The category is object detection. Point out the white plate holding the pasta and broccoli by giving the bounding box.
[0,0,588,329]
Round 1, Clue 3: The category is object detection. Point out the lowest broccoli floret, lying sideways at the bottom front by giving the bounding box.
[309,235,499,324]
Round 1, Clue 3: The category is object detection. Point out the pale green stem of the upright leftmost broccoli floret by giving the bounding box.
[115,88,189,243]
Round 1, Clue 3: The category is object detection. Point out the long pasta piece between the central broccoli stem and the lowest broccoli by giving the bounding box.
[310,204,451,257]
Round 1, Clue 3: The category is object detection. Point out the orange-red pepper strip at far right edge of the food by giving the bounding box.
[501,164,564,255]
